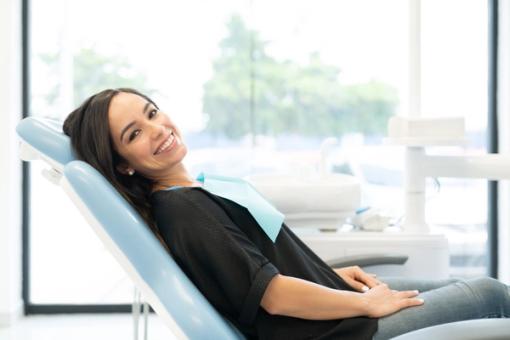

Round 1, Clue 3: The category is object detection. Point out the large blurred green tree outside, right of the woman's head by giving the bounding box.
[203,15,397,139]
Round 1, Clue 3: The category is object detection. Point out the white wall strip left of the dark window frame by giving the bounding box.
[0,0,22,327]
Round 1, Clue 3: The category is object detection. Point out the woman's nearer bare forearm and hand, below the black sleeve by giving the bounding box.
[260,274,423,320]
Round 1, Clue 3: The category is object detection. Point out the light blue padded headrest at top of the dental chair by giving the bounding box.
[16,117,76,172]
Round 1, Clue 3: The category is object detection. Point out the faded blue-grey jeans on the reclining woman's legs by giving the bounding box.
[373,277,510,340]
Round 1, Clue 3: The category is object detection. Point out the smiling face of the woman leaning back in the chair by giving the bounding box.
[108,92,187,180]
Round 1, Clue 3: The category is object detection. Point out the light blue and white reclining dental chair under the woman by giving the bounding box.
[17,117,510,340]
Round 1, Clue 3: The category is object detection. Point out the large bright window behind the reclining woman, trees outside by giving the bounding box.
[30,0,487,304]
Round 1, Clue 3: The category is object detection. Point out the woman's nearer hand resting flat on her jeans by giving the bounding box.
[363,283,423,318]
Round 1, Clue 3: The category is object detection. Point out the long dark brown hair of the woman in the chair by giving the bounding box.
[63,88,159,235]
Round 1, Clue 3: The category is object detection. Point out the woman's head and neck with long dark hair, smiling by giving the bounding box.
[63,88,204,234]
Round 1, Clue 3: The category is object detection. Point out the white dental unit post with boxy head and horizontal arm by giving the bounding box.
[385,116,510,234]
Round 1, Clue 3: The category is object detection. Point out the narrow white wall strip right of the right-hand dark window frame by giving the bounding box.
[498,0,510,283]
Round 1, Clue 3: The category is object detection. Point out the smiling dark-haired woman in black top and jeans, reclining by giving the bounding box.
[64,89,510,340]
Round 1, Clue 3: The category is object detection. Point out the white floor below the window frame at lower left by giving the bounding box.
[0,314,176,340]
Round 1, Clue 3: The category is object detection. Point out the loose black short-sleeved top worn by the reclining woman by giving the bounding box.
[151,187,377,340]
